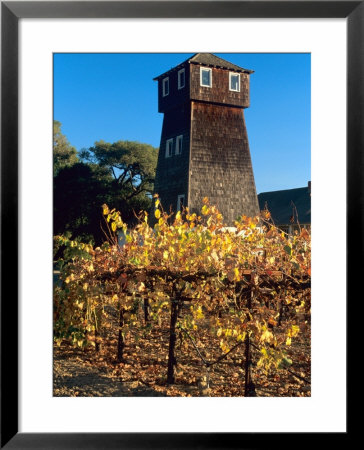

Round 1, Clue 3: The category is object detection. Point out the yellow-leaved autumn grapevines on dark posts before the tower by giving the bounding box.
[54,196,311,396]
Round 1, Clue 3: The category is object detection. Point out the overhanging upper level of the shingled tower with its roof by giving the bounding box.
[154,53,253,112]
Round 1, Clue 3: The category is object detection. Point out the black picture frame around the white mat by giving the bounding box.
[0,0,358,449]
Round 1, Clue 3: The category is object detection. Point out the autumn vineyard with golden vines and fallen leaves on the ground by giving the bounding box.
[54,197,311,397]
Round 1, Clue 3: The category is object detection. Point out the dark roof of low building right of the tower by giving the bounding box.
[258,187,311,225]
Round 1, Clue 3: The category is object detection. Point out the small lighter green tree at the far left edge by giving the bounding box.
[53,120,79,176]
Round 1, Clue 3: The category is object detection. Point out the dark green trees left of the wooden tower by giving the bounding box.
[54,125,158,245]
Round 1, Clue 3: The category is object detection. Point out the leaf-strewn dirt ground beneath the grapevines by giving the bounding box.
[53,322,311,397]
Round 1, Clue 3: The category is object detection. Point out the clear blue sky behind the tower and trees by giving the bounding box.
[53,53,311,193]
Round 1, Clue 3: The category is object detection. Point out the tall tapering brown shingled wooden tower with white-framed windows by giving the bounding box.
[154,53,259,225]
